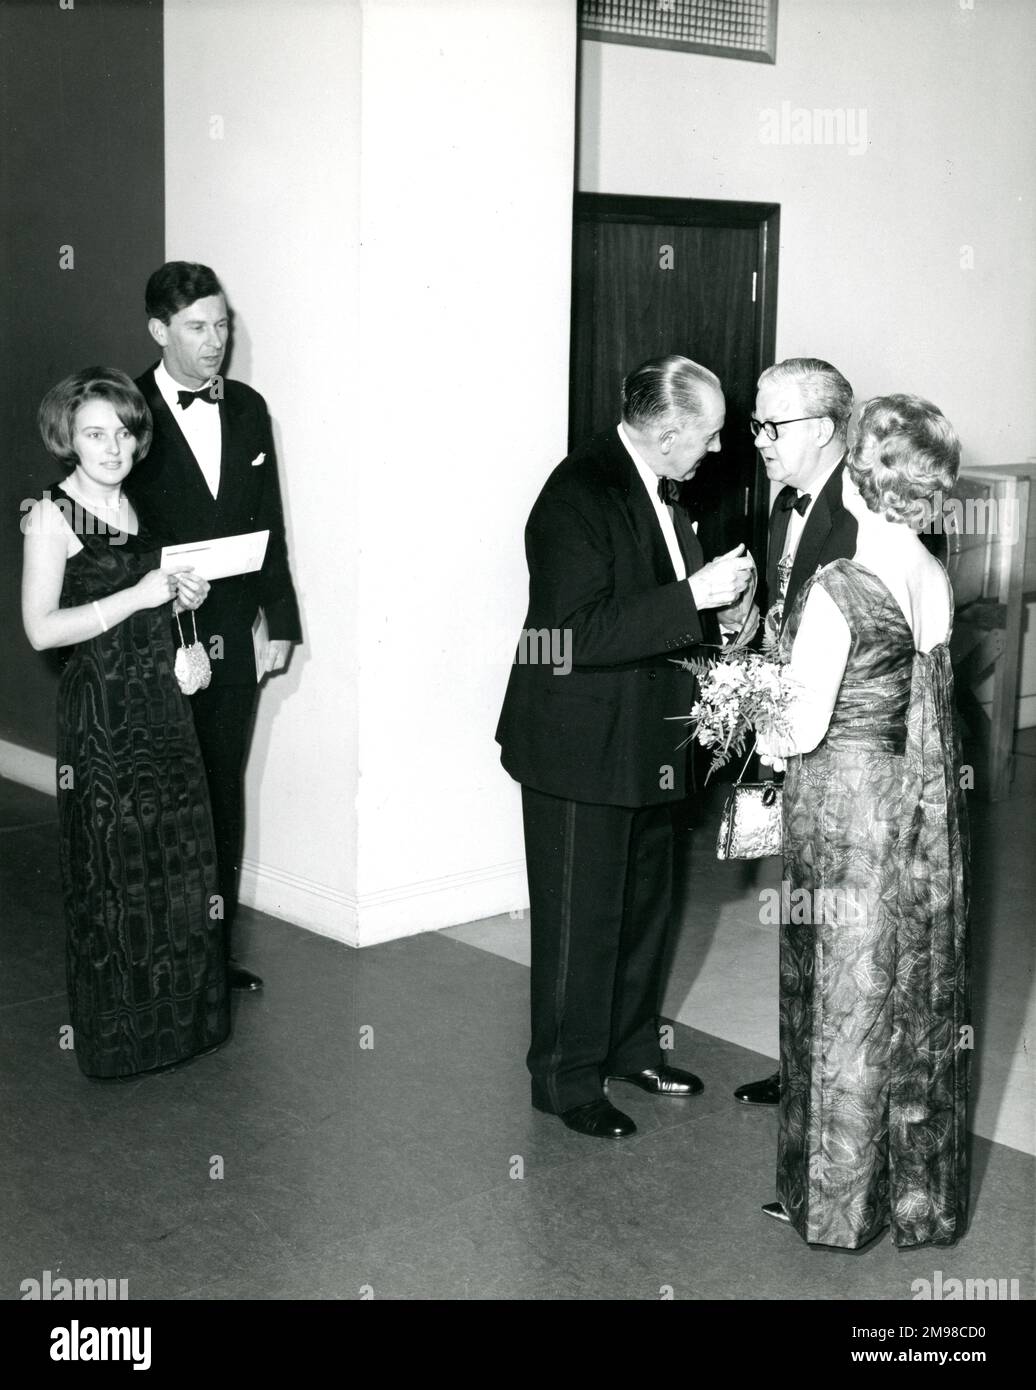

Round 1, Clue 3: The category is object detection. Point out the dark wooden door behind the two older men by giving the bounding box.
[569,193,779,567]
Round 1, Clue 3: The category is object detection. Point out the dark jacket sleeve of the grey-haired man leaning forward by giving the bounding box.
[526,496,702,666]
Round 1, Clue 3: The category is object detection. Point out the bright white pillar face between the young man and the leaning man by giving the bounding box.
[359,0,576,941]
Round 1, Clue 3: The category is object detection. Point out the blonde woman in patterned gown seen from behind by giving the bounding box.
[759,395,969,1248]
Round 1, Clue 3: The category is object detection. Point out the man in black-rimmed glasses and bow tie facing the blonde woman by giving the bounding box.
[734,357,857,1105]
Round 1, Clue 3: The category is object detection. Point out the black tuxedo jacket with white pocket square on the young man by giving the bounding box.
[125,368,302,685]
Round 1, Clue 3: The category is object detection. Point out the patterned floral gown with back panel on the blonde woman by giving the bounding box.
[777,560,971,1248]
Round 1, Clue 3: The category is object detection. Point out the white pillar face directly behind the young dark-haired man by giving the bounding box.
[164,0,362,940]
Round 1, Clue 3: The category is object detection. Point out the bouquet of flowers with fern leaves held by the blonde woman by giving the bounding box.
[679,646,794,781]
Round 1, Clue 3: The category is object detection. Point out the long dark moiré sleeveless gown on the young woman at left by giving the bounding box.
[50,484,229,1077]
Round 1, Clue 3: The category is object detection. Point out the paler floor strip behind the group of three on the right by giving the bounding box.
[446,728,1036,1155]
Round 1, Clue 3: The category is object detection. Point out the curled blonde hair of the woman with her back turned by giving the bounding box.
[845,395,961,528]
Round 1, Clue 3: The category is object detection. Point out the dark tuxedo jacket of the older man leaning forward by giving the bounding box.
[496,430,719,806]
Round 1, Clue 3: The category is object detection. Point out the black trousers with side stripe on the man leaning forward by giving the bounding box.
[521,787,673,1113]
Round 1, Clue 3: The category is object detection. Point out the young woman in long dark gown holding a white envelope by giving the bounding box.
[22,367,229,1077]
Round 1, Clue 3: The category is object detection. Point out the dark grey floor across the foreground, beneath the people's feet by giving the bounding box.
[0,781,1033,1300]
